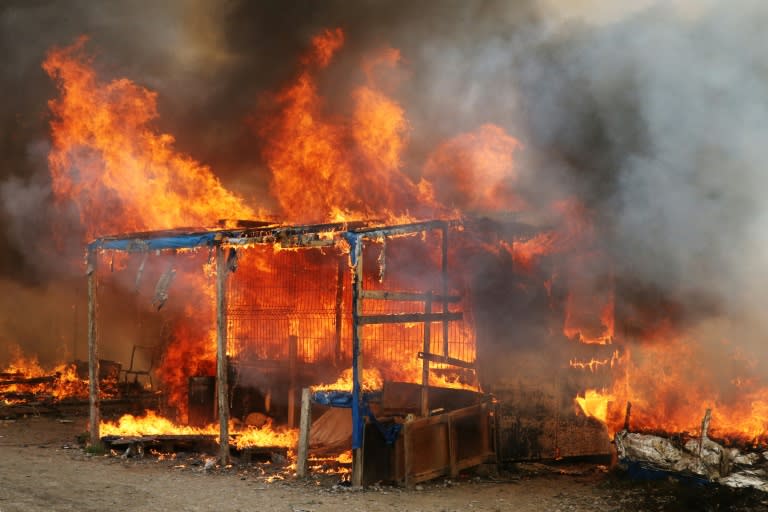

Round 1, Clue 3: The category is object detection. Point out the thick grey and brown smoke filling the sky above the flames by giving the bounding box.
[0,0,768,380]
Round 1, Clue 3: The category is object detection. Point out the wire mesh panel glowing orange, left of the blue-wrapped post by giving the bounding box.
[227,246,343,363]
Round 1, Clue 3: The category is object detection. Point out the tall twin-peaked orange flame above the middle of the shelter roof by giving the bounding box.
[260,29,432,222]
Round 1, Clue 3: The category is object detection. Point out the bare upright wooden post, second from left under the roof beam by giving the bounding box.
[216,244,229,465]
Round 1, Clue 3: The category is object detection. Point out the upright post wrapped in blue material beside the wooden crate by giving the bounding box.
[350,238,363,487]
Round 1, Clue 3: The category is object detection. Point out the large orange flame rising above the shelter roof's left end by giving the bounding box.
[43,38,255,240]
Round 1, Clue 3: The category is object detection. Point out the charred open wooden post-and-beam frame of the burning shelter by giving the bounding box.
[86,220,474,474]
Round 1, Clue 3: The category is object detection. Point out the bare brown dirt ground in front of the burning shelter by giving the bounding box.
[0,417,768,512]
